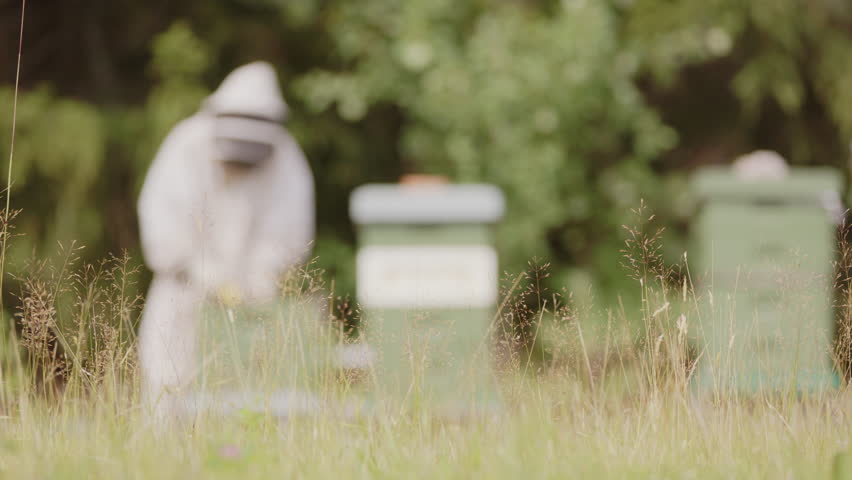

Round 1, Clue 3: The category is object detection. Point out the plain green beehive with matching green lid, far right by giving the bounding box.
[689,167,841,392]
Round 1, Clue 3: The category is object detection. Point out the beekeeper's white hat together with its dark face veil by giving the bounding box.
[203,62,287,164]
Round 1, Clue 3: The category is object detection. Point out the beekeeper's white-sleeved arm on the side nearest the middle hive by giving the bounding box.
[250,135,315,297]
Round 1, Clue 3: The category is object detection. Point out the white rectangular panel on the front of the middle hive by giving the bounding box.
[357,245,497,308]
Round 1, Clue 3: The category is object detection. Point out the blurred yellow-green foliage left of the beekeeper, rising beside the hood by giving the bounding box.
[0,22,210,304]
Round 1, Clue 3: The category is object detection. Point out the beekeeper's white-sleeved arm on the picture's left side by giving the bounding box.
[138,119,207,279]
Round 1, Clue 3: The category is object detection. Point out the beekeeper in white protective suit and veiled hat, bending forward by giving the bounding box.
[138,62,314,413]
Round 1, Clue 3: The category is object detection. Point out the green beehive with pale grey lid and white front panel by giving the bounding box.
[350,184,504,415]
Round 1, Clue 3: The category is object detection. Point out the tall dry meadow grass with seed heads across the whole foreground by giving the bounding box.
[0,201,852,478]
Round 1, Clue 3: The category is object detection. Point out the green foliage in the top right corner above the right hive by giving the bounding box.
[623,0,852,150]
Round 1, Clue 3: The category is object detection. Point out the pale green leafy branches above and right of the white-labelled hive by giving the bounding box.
[296,2,675,286]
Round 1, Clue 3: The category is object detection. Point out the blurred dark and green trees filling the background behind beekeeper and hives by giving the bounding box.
[0,0,852,318]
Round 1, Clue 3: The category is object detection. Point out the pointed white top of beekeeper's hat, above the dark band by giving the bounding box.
[204,62,287,122]
